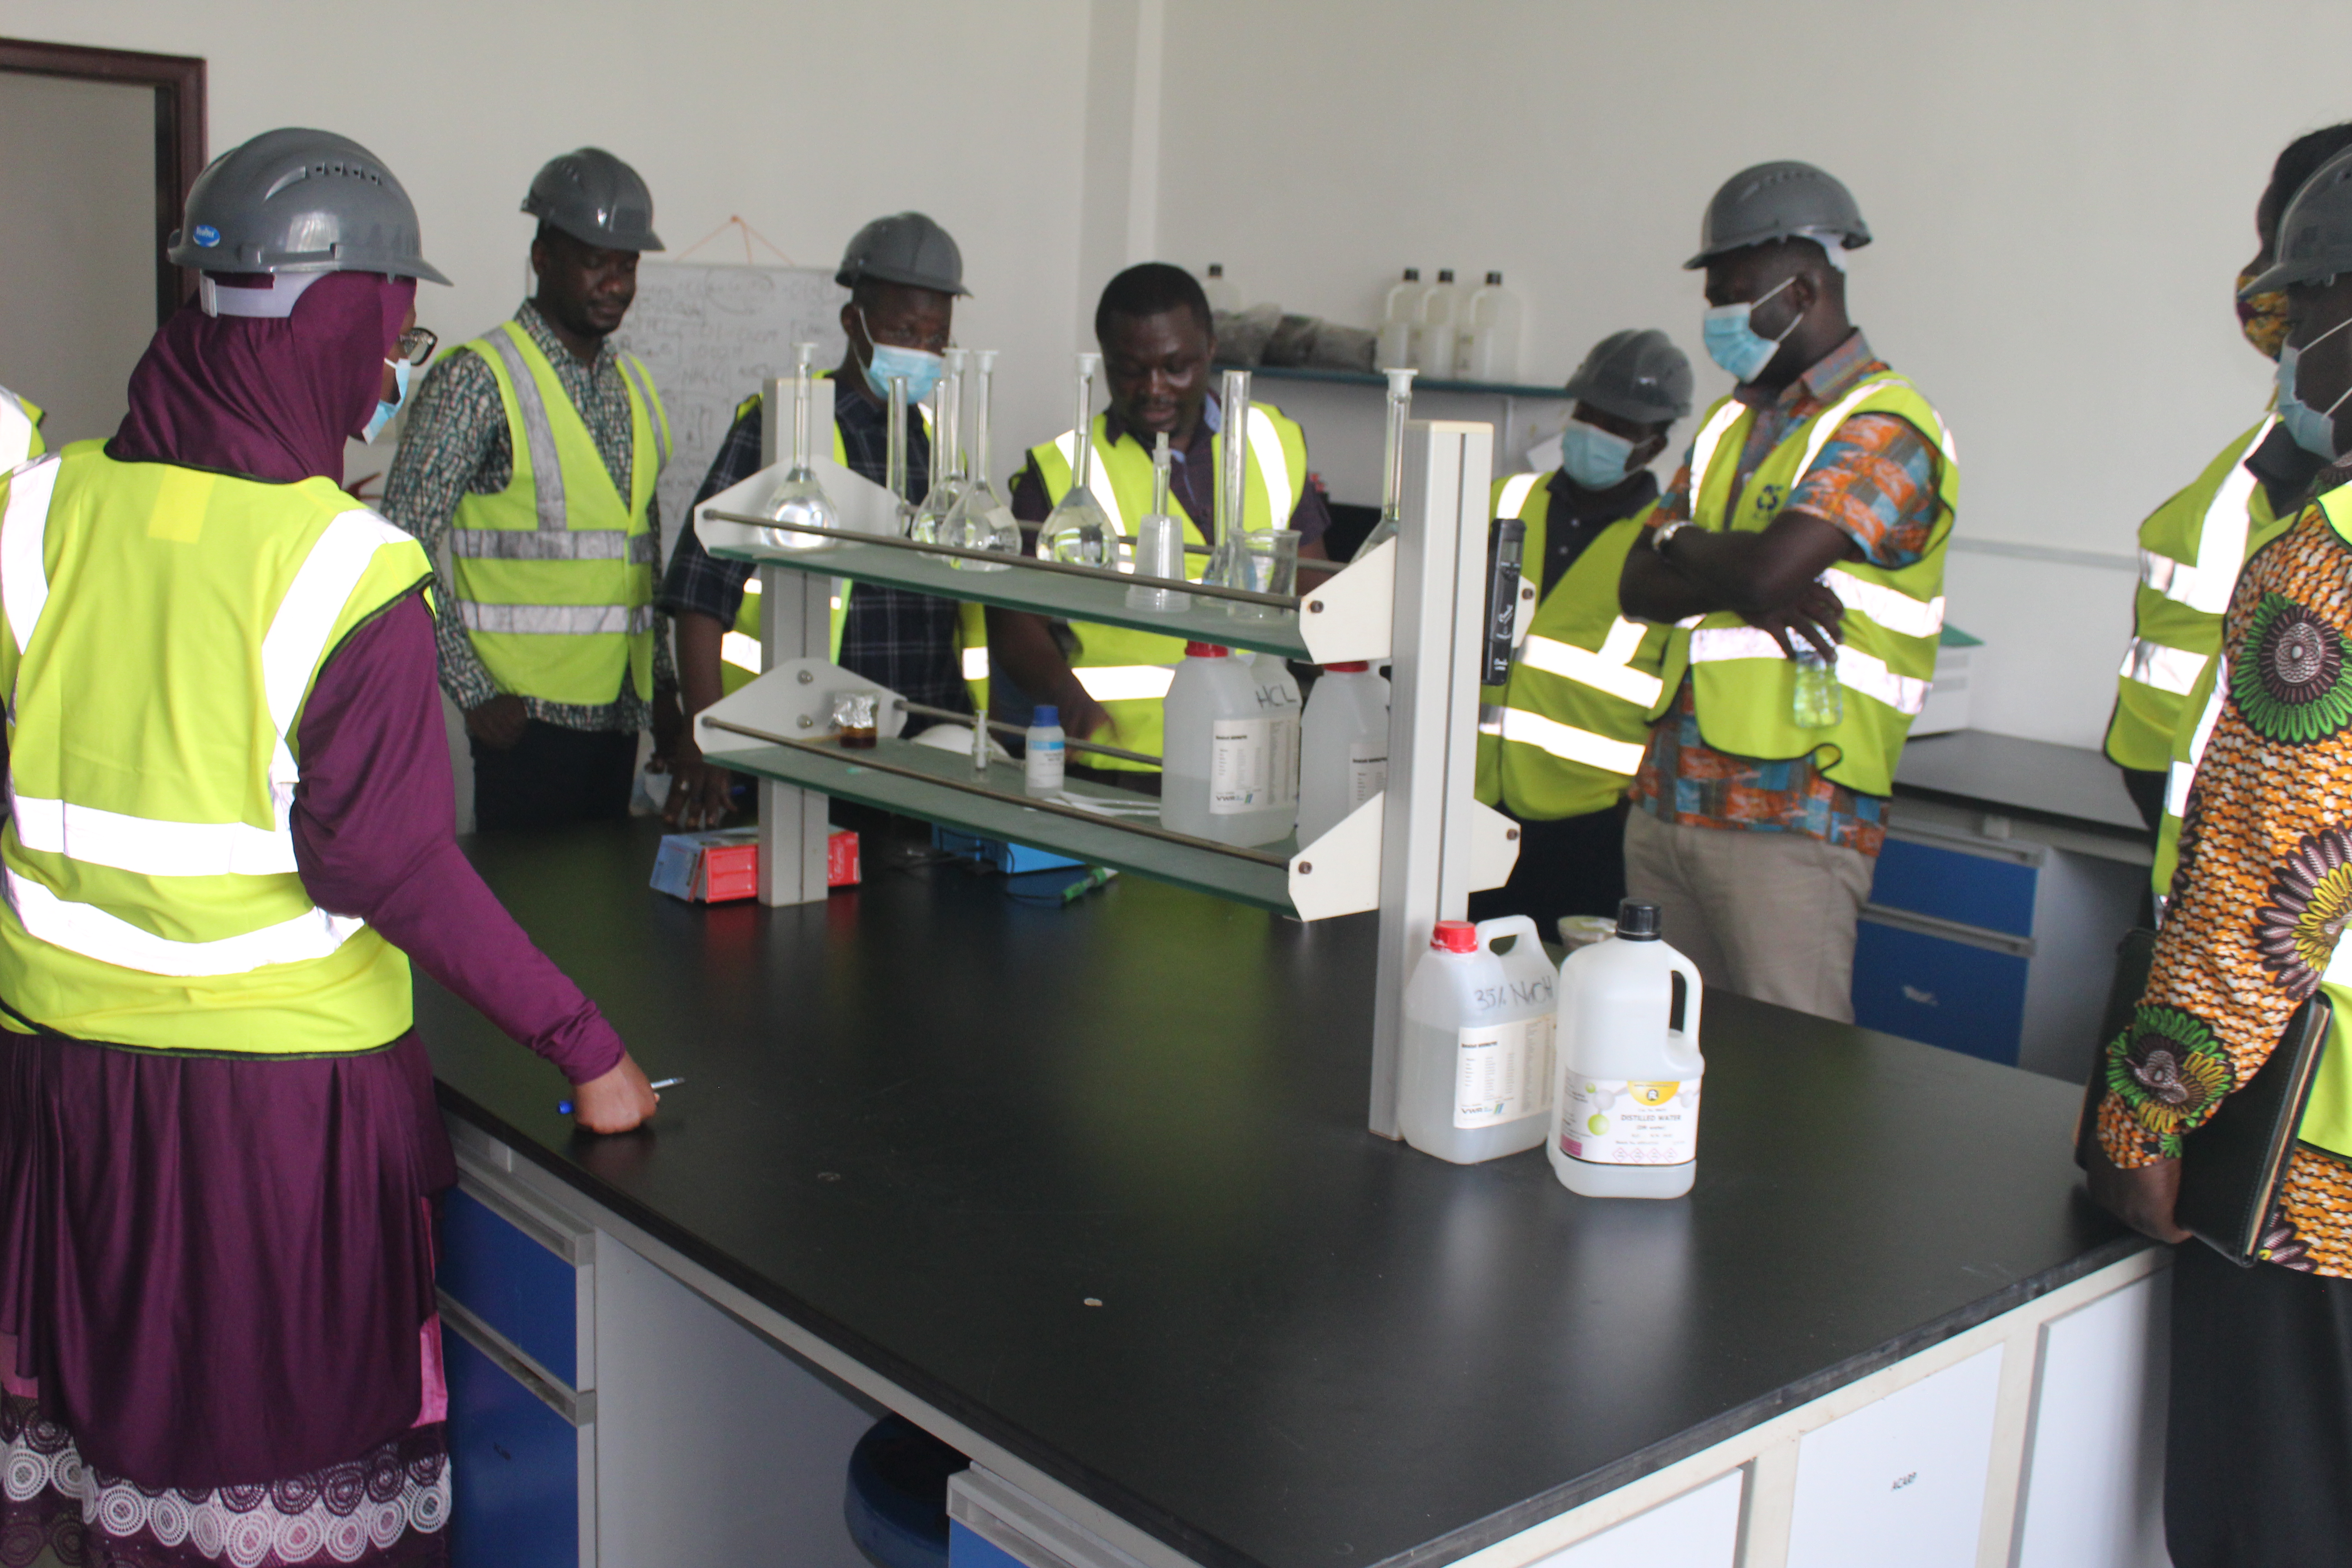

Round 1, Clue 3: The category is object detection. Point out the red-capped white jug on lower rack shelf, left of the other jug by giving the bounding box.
[1160,642,1298,846]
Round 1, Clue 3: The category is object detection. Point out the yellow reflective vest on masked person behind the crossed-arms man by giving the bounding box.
[1477,472,1670,823]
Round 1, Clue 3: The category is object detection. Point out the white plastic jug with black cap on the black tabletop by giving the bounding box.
[1543,898,1708,1199]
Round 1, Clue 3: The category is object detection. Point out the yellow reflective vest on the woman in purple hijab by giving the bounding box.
[0,442,431,1055]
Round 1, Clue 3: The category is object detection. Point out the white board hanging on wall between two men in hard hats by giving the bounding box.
[614,261,849,562]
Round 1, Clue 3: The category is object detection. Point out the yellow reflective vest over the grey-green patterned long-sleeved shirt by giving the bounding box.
[449,322,670,705]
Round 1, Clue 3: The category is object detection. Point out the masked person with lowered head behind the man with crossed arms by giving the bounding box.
[1470,329,1691,933]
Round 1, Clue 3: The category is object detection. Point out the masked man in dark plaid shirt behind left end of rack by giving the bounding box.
[661,211,981,828]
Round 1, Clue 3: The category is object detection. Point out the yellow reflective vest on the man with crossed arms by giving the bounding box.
[1651,372,1959,794]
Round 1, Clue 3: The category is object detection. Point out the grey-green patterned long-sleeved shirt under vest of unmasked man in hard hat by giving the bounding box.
[383,301,677,731]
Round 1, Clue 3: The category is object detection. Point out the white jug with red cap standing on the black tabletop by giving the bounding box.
[1397,915,1557,1166]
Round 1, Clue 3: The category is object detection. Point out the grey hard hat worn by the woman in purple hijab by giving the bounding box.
[165,127,449,282]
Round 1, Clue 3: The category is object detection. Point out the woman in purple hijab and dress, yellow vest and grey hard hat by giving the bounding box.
[0,132,656,1568]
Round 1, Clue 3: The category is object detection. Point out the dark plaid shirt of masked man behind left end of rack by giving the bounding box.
[659,376,971,712]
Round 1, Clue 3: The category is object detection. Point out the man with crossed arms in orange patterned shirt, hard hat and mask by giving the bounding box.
[1618,162,1959,1020]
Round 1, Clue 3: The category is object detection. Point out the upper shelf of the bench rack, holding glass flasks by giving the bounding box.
[710,526,1308,661]
